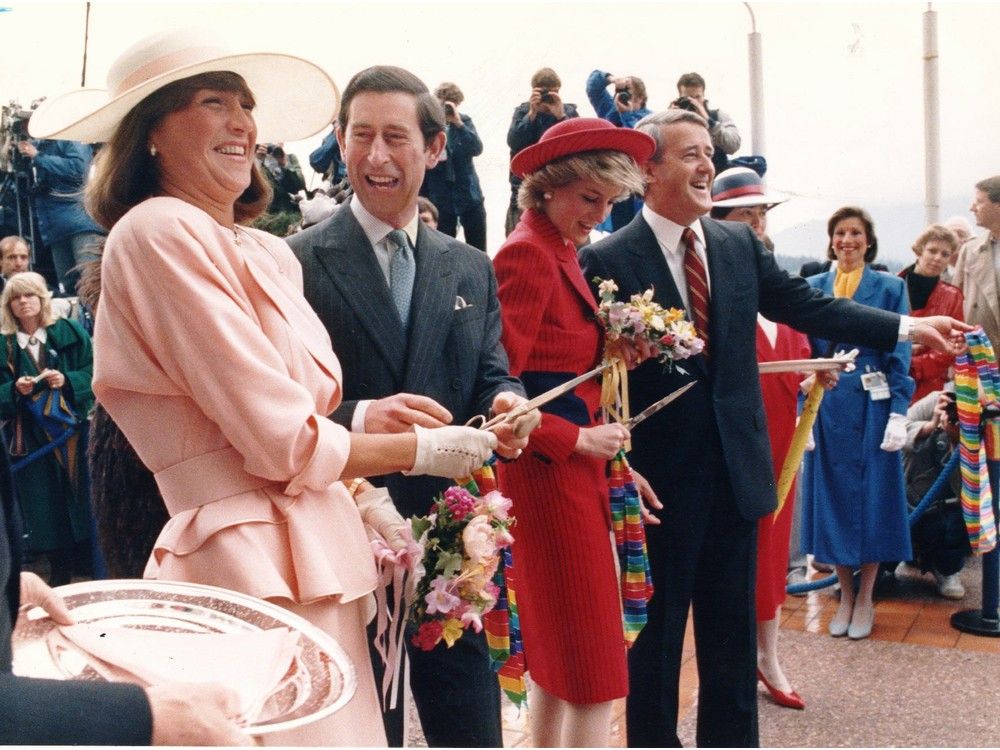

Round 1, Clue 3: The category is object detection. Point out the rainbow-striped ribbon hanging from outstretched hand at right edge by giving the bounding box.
[955,328,1000,554]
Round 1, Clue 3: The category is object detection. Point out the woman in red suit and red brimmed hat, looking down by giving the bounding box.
[494,118,654,747]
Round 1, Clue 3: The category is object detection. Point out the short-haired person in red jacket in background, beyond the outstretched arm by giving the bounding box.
[899,224,965,404]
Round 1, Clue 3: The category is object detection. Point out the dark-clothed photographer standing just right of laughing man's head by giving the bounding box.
[420,82,486,252]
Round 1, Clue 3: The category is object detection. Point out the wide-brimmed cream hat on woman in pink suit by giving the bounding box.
[28,29,340,143]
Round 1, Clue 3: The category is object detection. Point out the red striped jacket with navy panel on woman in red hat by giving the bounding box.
[493,209,604,461]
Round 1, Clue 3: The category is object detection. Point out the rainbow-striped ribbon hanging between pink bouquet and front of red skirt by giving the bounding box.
[464,464,528,708]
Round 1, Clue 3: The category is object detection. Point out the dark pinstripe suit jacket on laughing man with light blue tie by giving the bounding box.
[288,209,524,516]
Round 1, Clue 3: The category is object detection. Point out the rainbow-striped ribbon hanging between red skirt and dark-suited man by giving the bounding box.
[609,449,653,647]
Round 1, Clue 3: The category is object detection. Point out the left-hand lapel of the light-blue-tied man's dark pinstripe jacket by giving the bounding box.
[313,204,406,381]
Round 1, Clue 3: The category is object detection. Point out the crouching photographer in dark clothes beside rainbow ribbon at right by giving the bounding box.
[896,384,971,599]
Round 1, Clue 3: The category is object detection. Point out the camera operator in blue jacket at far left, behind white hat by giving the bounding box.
[17,139,105,296]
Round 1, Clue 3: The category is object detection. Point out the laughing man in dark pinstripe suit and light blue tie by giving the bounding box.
[289,66,526,747]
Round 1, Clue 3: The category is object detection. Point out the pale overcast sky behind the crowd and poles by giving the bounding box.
[0,0,1000,257]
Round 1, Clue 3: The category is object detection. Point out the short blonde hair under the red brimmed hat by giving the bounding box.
[517,150,645,209]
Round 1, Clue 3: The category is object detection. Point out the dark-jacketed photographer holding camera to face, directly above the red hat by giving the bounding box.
[504,68,580,236]
